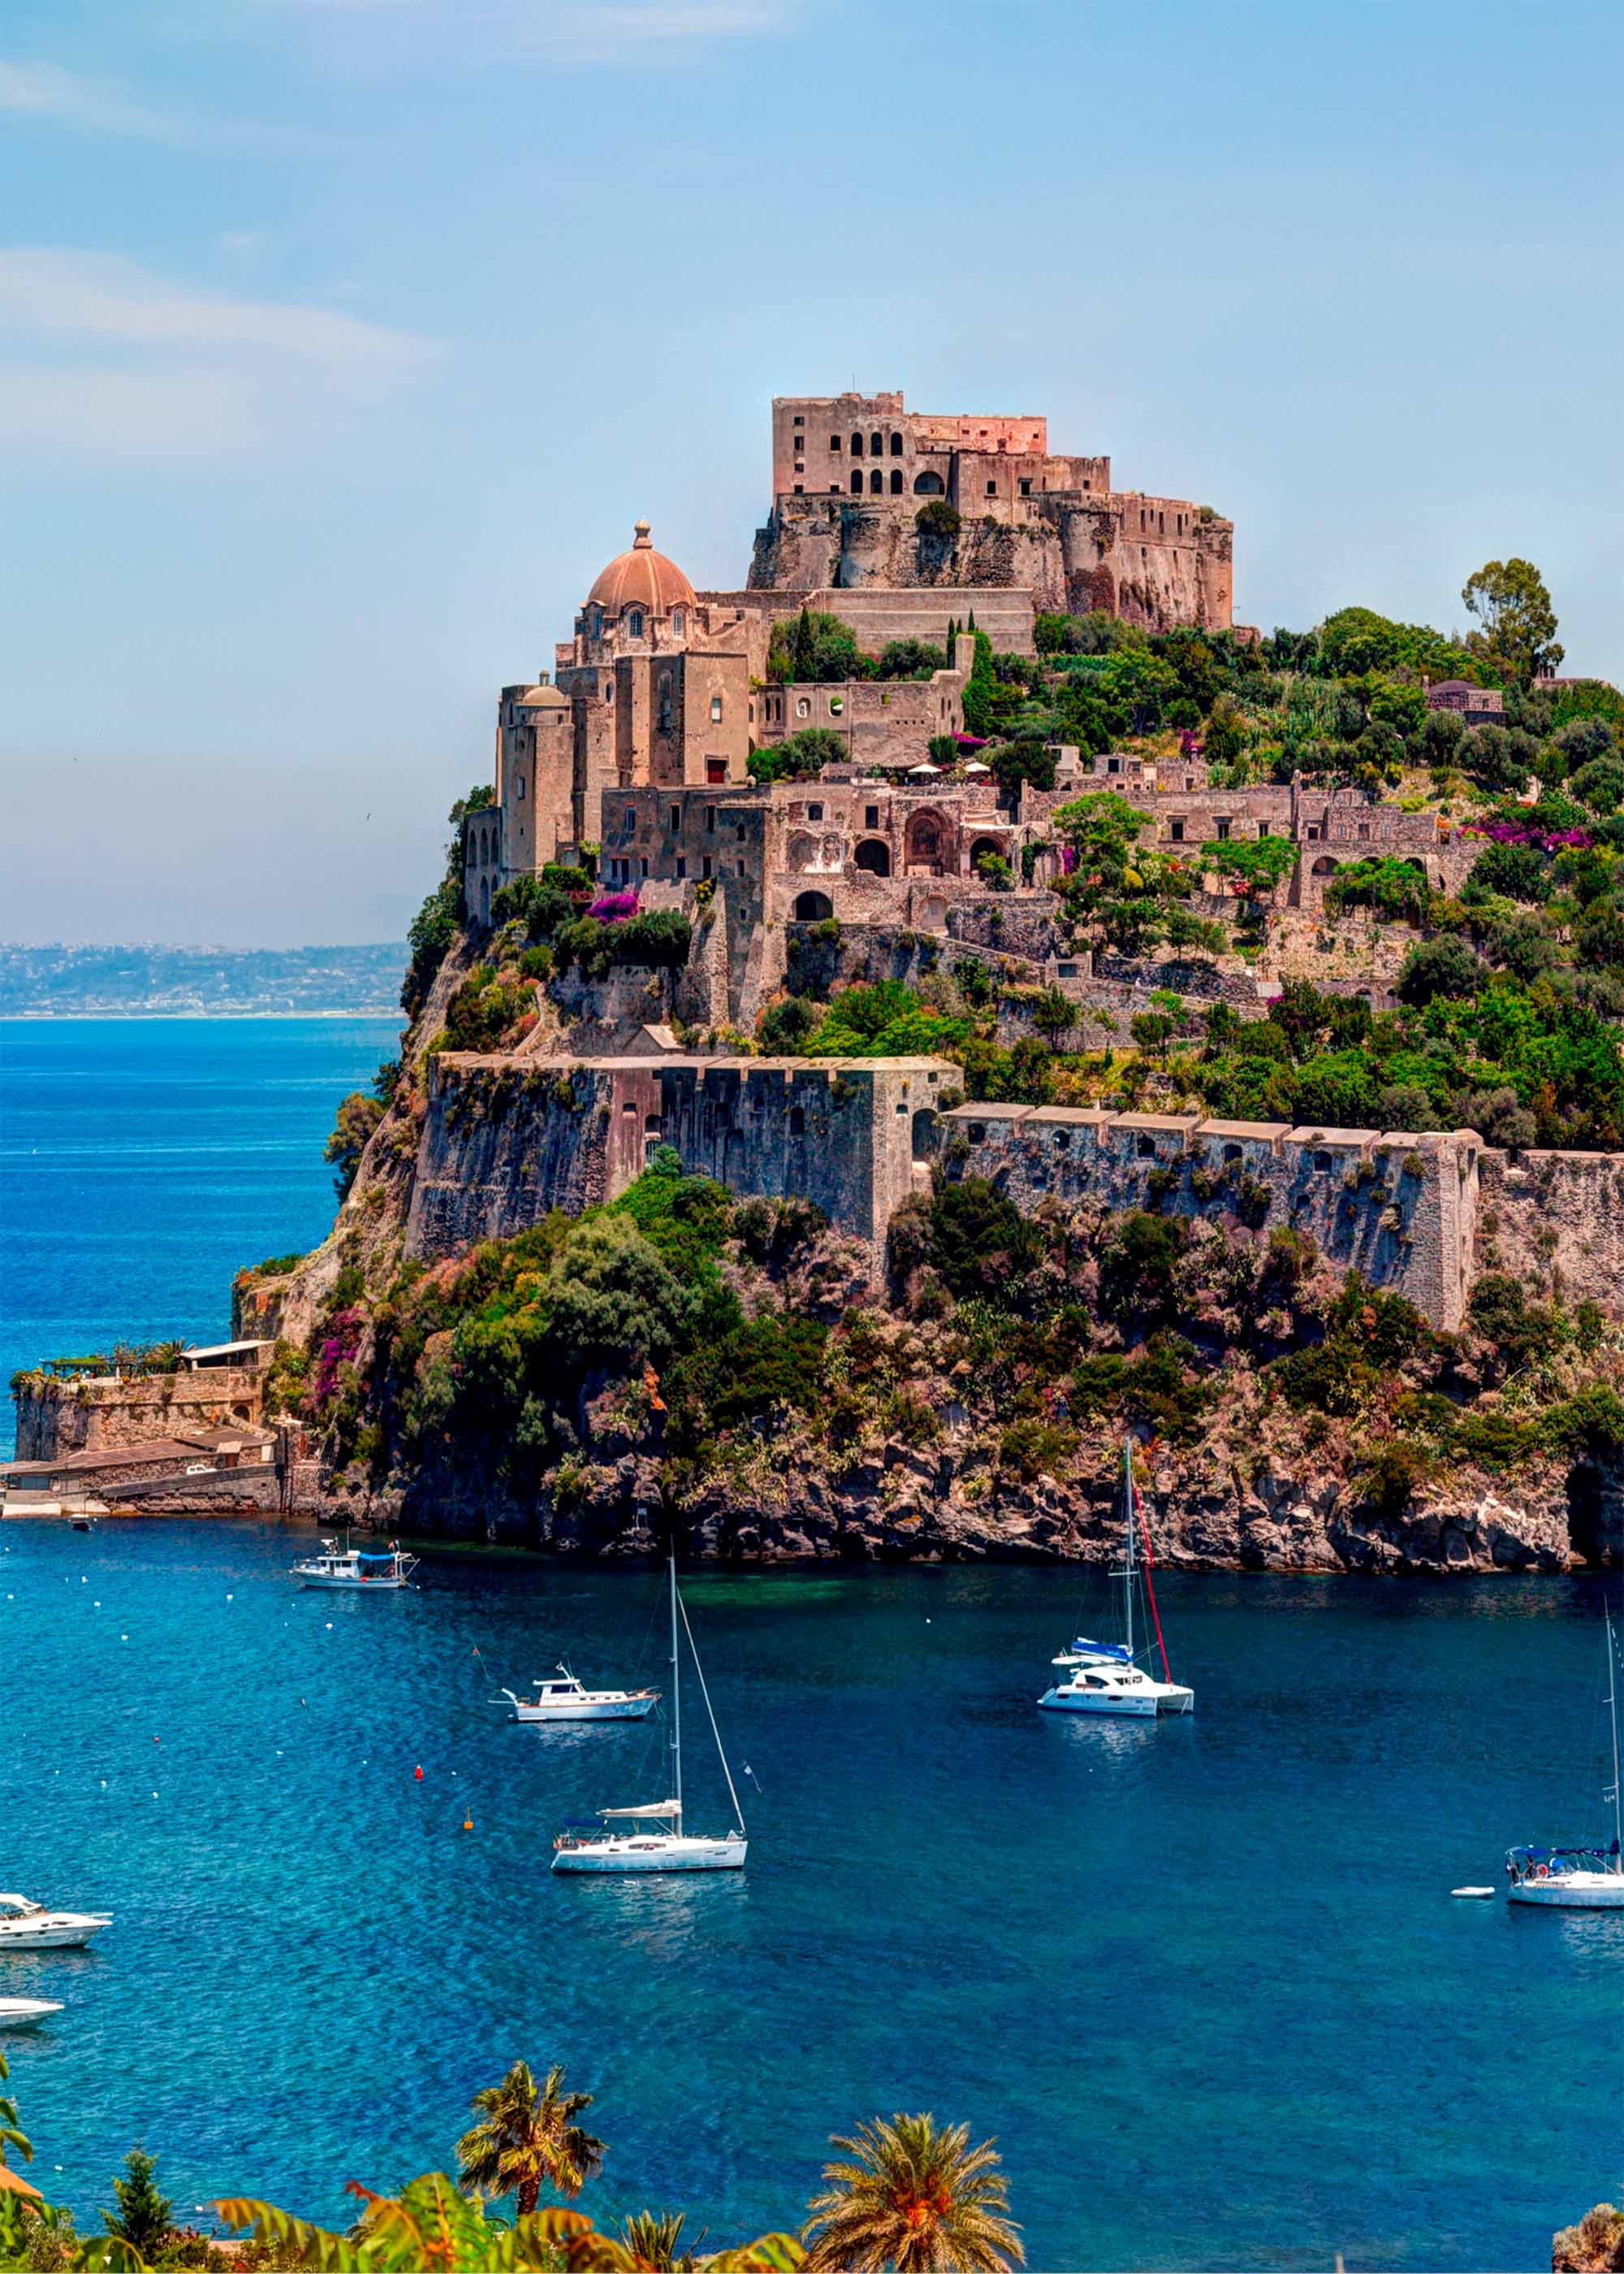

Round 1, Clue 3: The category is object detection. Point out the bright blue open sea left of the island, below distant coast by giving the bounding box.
[0,1018,400,1458]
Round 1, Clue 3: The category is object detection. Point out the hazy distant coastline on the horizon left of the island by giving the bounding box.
[0,939,407,1018]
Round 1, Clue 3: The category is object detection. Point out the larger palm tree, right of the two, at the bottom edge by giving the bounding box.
[803,2115,1026,2274]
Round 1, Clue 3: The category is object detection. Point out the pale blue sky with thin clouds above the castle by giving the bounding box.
[0,0,1624,944]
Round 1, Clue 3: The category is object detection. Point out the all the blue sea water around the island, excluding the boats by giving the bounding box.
[0,1021,1624,2269]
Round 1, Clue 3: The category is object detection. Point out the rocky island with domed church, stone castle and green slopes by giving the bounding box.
[11,396,1624,1571]
